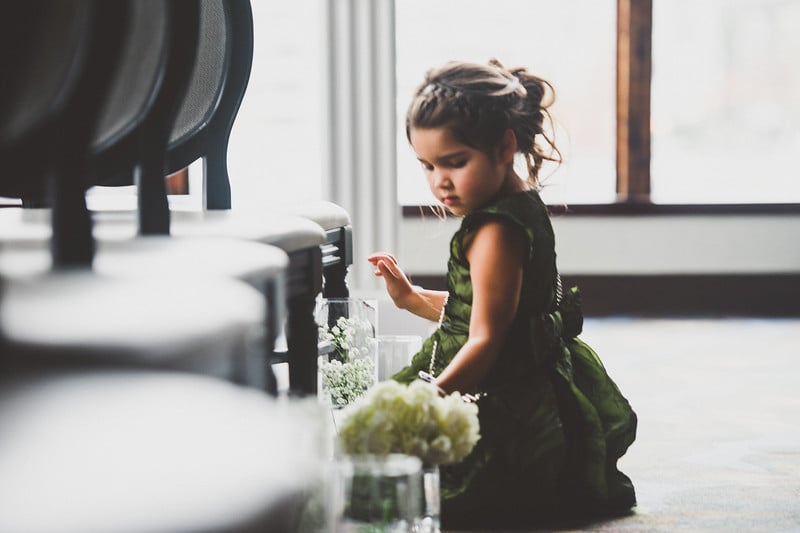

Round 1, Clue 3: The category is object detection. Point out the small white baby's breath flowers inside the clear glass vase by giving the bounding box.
[319,317,376,408]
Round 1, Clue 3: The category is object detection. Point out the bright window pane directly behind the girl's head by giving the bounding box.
[395,0,616,205]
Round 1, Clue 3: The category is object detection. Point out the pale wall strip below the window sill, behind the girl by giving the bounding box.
[398,215,800,275]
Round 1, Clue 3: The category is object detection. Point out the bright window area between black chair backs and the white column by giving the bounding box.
[227,1,324,209]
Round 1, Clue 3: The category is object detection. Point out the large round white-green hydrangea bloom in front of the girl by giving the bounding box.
[339,380,480,465]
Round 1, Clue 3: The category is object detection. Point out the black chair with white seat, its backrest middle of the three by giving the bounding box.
[0,1,288,393]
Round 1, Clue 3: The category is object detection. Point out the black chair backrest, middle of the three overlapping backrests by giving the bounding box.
[91,0,200,235]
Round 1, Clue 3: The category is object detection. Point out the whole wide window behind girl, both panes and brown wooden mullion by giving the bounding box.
[396,0,800,205]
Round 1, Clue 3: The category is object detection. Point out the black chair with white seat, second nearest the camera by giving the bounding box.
[0,0,266,388]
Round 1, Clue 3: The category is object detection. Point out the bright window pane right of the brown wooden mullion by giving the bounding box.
[651,0,800,203]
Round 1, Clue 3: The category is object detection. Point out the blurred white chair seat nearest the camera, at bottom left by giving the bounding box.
[0,371,329,533]
